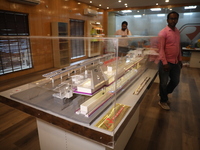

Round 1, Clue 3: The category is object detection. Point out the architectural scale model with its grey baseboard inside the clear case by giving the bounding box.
[8,36,158,120]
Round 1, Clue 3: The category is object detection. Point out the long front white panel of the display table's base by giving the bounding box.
[37,119,106,150]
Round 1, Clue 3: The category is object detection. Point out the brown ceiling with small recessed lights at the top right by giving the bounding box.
[77,0,200,10]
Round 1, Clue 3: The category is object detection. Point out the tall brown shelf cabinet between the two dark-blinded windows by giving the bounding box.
[51,22,70,68]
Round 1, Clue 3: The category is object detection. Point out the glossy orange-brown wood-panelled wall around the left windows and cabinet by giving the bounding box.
[0,0,106,81]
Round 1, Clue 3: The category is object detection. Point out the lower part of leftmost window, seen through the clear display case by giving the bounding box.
[0,38,32,75]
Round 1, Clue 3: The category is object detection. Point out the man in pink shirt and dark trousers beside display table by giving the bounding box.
[158,11,182,110]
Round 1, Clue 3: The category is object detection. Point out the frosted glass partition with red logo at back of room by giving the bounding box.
[108,5,200,66]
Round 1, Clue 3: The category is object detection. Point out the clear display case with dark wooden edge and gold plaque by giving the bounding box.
[1,37,159,149]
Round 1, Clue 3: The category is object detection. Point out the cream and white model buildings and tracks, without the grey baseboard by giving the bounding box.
[40,48,158,117]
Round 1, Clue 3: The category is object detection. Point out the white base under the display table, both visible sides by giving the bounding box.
[37,107,140,150]
